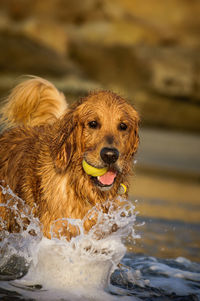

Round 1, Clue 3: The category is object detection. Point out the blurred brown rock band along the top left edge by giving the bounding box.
[0,0,103,23]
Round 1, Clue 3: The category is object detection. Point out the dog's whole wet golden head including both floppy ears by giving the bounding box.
[52,91,139,195]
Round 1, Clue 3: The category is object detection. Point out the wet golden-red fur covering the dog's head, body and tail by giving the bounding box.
[0,78,139,239]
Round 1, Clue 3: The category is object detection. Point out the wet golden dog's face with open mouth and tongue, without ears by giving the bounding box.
[77,92,139,190]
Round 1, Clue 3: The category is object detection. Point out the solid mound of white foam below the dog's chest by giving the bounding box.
[19,238,125,290]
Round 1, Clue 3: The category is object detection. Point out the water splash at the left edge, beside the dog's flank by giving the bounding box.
[0,185,42,280]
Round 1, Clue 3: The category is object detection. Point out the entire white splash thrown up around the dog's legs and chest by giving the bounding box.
[0,186,138,300]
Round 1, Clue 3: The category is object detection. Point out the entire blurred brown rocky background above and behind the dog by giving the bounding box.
[0,0,200,132]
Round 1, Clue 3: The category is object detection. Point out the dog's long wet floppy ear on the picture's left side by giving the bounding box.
[50,110,78,173]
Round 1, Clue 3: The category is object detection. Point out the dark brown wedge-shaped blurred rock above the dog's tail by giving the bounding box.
[0,31,78,76]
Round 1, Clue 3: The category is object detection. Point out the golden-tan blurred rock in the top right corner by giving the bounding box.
[116,0,200,47]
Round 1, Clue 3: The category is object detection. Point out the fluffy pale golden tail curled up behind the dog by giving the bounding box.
[0,77,67,127]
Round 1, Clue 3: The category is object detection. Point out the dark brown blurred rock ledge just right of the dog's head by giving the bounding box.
[134,91,200,132]
